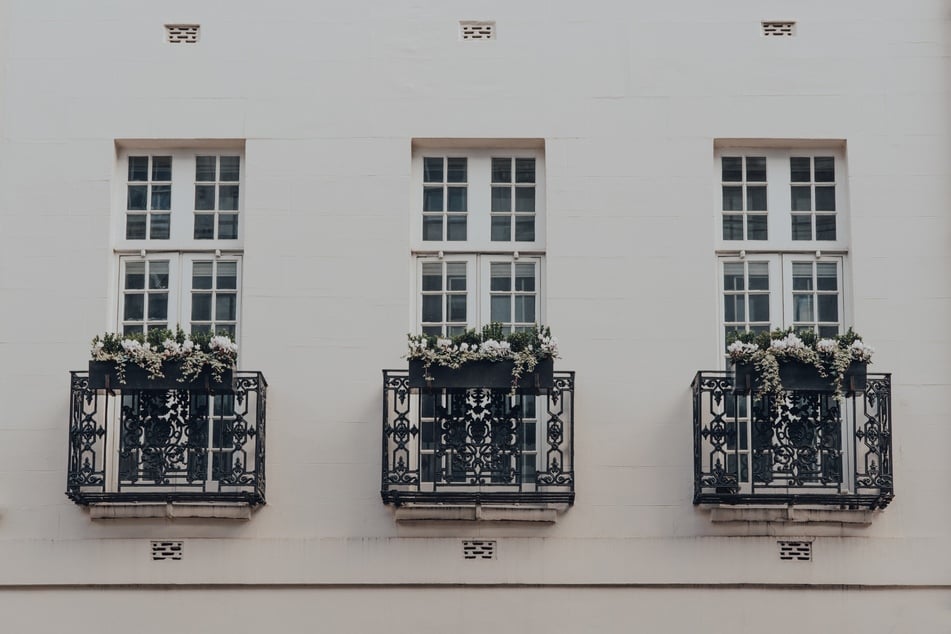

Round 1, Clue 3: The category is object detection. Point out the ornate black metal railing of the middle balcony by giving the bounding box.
[381,370,575,505]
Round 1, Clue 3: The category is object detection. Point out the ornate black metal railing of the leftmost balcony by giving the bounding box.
[66,371,267,505]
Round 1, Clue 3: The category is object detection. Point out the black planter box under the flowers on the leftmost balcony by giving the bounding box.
[89,361,234,392]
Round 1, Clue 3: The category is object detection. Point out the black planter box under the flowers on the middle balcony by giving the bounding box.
[409,358,555,390]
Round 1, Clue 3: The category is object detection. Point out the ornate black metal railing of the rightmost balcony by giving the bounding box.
[692,371,894,509]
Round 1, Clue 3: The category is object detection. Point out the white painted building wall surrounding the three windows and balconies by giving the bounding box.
[0,0,951,632]
